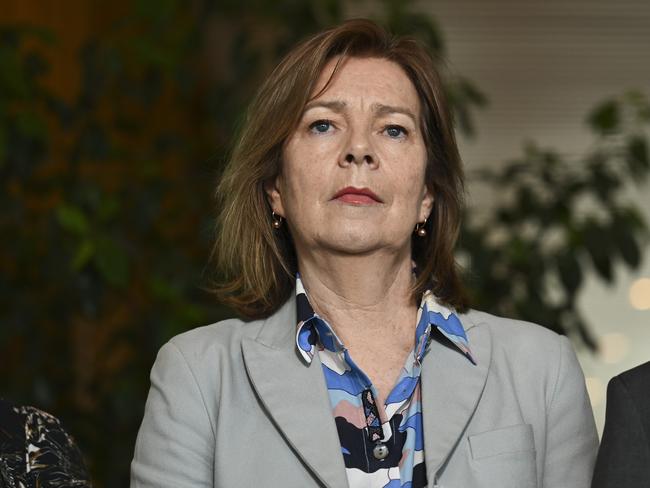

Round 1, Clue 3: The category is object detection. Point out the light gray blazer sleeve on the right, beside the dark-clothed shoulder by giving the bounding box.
[542,336,598,488]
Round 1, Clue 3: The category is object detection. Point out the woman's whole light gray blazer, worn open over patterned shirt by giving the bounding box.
[131,298,598,488]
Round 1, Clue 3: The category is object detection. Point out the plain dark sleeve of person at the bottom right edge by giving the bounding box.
[592,376,650,488]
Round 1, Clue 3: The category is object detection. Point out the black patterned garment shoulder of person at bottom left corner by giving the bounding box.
[0,401,91,488]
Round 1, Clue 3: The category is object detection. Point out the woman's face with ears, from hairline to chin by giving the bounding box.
[266,58,433,257]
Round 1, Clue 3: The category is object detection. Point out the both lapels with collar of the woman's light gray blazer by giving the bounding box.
[242,294,492,488]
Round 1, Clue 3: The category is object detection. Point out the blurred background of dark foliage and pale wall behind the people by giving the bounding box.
[0,0,650,487]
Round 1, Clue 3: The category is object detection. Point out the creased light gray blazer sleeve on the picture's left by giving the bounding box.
[131,342,215,488]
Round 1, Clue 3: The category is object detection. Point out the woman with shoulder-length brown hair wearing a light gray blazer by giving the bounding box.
[131,20,597,488]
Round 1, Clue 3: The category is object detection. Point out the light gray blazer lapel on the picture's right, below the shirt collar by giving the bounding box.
[421,315,492,487]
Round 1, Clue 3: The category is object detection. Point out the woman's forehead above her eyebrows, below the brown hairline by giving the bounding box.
[311,57,420,113]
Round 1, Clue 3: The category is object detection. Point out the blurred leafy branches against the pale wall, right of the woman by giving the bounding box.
[460,93,650,349]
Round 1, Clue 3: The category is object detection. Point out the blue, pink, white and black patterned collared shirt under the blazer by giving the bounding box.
[296,275,476,488]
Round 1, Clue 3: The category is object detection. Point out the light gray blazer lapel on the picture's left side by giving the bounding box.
[242,295,348,488]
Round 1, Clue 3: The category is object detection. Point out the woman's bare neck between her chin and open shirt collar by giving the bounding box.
[298,250,417,339]
